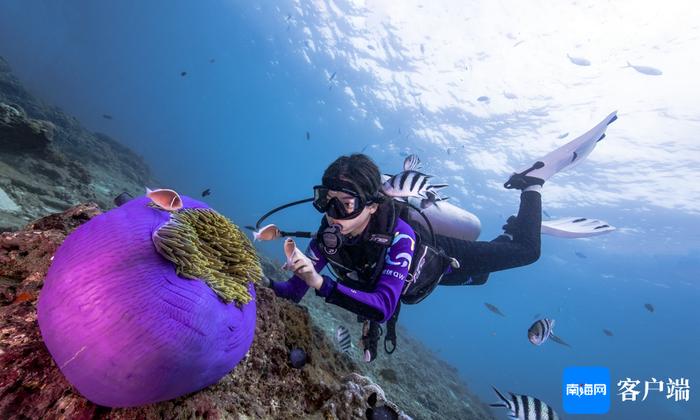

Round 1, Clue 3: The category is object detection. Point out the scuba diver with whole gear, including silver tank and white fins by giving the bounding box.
[254,113,617,362]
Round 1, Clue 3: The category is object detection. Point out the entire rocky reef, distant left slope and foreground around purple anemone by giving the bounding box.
[0,58,492,420]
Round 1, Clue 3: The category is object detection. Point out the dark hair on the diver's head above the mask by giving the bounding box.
[323,153,383,202]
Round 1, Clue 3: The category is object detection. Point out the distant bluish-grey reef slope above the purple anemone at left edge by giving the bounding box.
[0,57,159,231]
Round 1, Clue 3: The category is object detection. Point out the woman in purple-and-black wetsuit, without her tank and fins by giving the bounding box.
[270,154,543,361]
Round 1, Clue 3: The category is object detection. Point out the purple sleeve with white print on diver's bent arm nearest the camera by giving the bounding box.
[316,219,416,322]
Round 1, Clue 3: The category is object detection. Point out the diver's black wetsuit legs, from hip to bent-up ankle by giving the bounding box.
[435,191,542,286]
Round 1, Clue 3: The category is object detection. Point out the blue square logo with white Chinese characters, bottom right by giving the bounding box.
[562,366,610,414]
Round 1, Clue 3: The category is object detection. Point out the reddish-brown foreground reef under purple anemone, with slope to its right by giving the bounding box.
[0,203,491,419]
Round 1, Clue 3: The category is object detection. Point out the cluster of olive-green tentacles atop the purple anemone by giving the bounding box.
[153,209,263,304]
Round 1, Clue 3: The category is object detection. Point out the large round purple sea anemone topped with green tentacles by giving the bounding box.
[38,197,260,407]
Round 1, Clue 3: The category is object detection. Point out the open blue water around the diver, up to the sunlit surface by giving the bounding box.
[0,0,700,419]
